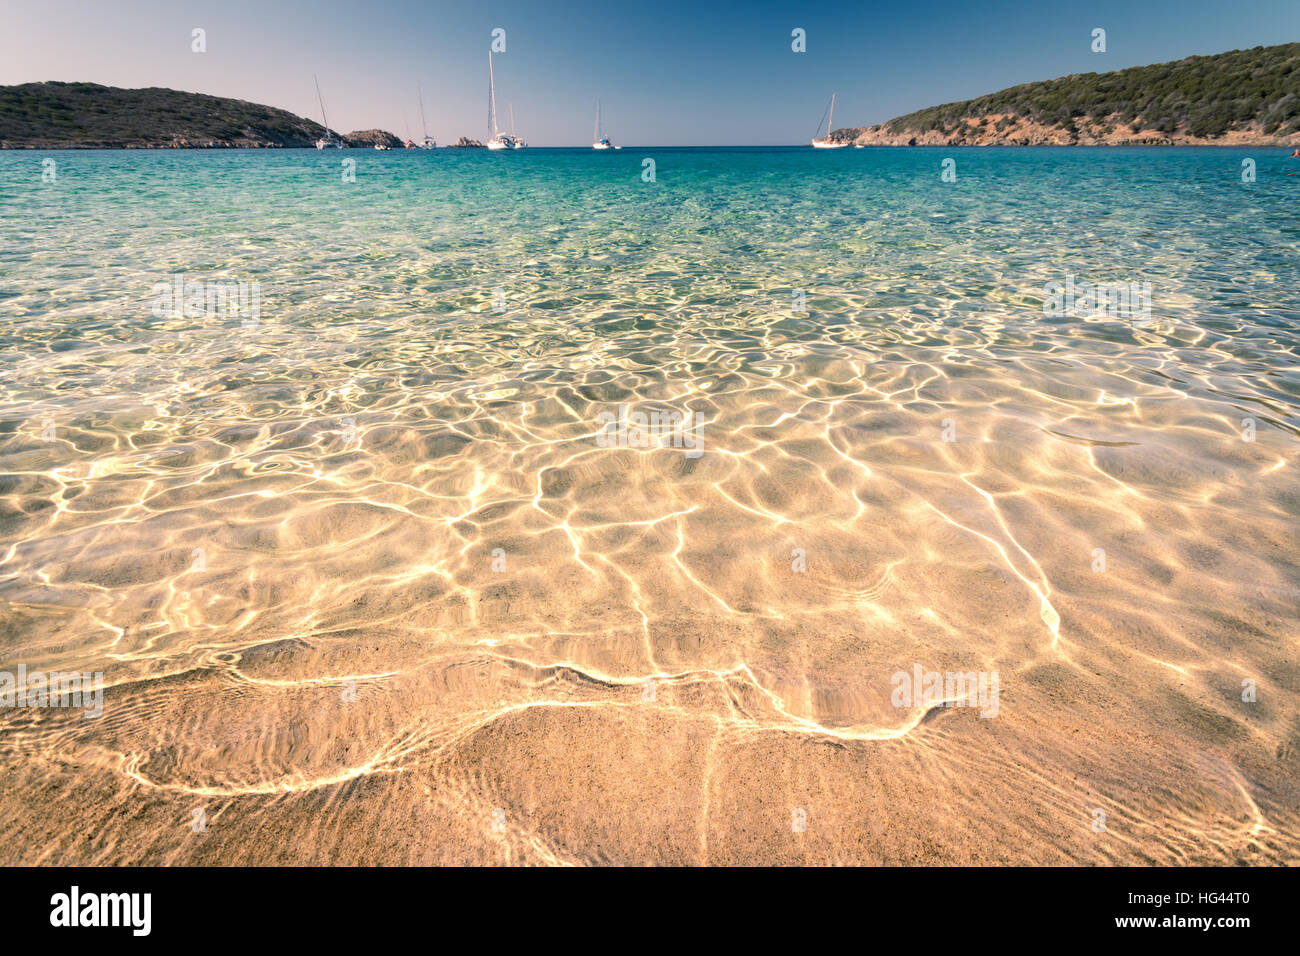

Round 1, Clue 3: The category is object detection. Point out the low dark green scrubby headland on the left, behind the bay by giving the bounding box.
[0,83,325,150]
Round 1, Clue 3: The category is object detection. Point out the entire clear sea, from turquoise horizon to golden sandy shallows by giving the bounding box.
[0,148,1300,864]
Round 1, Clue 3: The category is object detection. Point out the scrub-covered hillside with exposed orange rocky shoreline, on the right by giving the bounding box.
[831,43,1300,146]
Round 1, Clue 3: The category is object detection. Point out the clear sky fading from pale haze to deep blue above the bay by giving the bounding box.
[0,0,1300,146]
